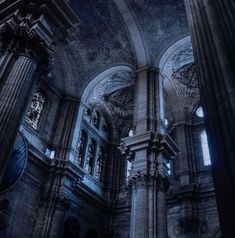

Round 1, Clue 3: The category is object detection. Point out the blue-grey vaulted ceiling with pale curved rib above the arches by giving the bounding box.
[50,0,188,97]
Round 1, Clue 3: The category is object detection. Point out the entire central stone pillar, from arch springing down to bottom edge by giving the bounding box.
[120,68,177,238]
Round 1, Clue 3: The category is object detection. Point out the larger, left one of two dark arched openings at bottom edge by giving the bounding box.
[63,217,80,238]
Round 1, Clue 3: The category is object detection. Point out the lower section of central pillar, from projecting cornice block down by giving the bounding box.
[120,131,178,238]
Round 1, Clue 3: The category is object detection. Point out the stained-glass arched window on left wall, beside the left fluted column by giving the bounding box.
[25,92,45,130]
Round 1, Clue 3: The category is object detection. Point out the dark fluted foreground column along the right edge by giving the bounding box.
[185,0,235,238]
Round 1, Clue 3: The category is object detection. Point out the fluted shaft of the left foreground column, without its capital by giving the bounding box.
[0,56,36,181]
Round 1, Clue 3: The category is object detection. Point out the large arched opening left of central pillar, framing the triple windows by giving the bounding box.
[70,66,134,186]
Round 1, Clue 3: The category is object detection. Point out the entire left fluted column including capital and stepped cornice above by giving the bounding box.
[0,0,79,182]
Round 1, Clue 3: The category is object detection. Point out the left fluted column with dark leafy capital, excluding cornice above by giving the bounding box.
[0,24,49,182]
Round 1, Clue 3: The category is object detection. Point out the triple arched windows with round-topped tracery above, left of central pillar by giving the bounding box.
[75,105,109,183]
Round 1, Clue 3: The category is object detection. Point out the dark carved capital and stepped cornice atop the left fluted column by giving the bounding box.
[0,0,79,76]
